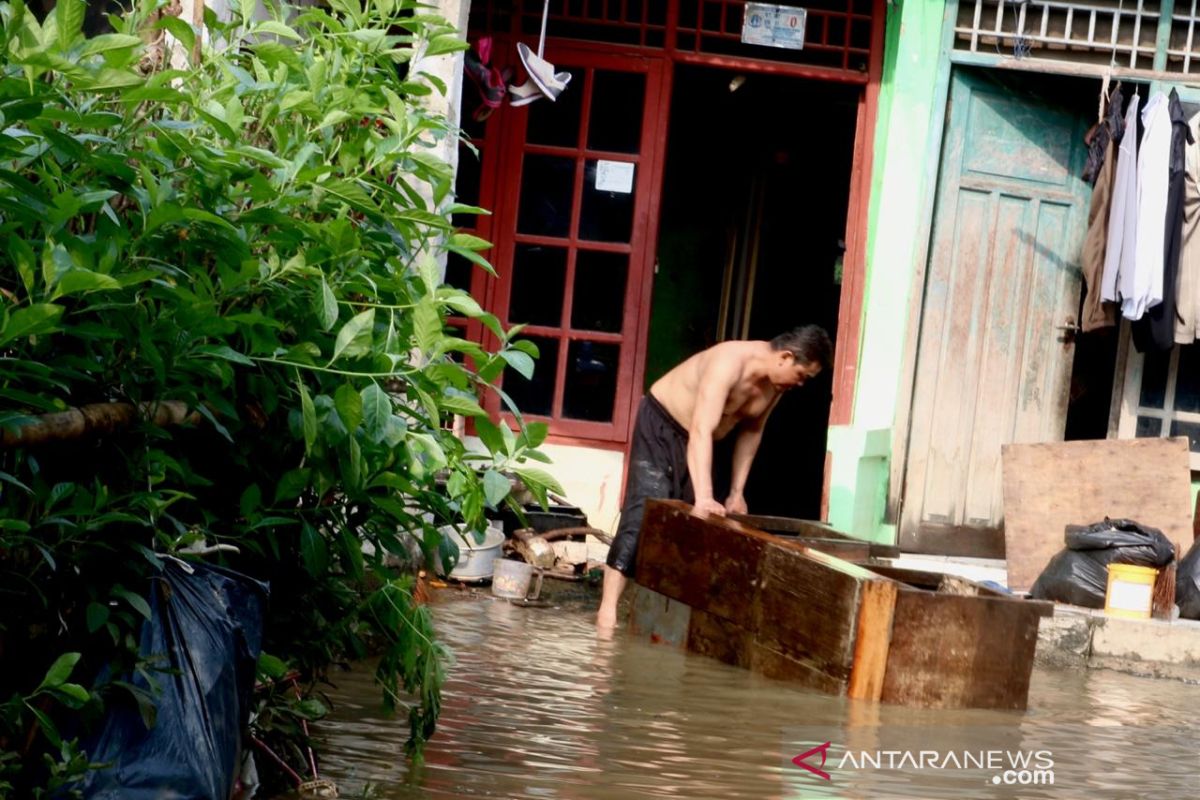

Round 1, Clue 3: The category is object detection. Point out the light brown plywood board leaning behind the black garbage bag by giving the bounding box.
[1003,437,1193,591]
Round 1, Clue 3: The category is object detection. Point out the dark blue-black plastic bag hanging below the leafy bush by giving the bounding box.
[82,559,268,800]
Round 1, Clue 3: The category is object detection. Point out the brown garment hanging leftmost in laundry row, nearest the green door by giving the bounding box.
[1081,86,1118,331]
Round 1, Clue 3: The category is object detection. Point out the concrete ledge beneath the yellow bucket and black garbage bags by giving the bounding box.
[1034,606,1200,682]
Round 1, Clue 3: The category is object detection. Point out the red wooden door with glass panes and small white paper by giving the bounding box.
[491,48,670,444]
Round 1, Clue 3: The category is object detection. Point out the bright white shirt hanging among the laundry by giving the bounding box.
[1118,92,1171,320]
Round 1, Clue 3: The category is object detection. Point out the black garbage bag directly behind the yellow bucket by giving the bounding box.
[1030,519,1175,608]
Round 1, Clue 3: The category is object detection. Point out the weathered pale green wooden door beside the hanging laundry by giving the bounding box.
[900,71,1094,555]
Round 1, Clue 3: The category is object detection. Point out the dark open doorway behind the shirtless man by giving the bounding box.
[644,65,863,519]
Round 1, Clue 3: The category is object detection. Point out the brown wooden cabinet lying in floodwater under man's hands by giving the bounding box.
[631,500,1052,709]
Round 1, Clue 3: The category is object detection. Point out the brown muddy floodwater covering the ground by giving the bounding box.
[318,591,1200,800]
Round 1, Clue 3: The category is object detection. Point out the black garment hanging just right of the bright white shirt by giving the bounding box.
[1133,89,1194,353]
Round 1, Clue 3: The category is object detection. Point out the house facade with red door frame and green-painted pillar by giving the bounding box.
[448,0,1200,555]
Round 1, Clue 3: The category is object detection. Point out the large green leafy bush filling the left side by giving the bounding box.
[0,0,554,795]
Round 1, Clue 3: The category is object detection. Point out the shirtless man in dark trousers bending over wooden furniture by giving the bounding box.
[596,325,832,628]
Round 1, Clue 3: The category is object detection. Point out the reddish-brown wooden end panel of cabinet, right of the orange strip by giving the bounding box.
[880,591,1049,709]
